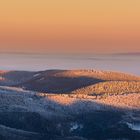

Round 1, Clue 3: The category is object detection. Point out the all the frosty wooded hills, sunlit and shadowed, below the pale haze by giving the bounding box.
[0,70,140,140]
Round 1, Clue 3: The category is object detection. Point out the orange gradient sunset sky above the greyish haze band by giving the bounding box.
[0,0,140,53]
